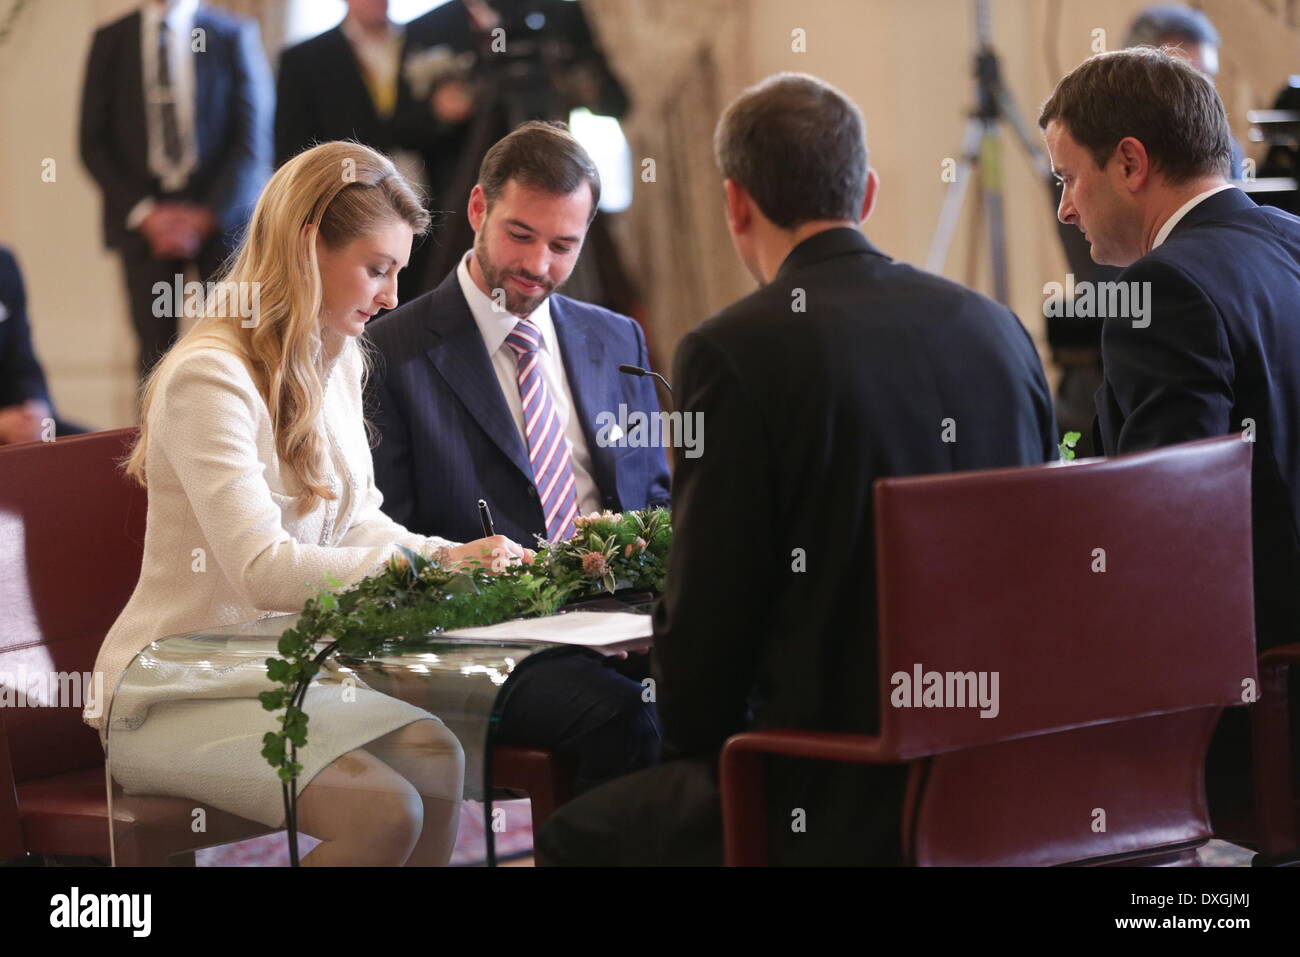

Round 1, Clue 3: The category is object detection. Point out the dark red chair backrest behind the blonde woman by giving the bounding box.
[0,429,147,781]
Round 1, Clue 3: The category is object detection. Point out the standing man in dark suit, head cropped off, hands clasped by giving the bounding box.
[81,0,273,378]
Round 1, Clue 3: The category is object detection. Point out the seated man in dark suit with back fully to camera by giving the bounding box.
[537,74,1056,865]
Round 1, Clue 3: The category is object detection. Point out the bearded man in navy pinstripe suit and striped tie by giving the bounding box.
[367,122,668,806]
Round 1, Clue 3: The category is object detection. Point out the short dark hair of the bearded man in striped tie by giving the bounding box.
[478,120,601,222]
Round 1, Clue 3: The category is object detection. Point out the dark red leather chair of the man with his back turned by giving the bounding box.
[720,438,1256,865]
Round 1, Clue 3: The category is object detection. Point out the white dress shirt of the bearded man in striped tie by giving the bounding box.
[456,250,601,515]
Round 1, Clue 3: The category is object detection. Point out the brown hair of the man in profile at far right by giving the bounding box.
[1039,47,1232,183]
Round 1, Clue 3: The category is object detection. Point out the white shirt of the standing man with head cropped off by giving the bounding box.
[126,0,199,229]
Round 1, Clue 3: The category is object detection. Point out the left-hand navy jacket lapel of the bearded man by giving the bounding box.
[426,270,533,481]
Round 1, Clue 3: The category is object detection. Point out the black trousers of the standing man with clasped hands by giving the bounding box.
[120,231,229,382]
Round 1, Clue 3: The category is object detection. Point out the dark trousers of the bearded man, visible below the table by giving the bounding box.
[497,649,662,794]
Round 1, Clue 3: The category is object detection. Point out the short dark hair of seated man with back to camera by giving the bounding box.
[714,73,867,229]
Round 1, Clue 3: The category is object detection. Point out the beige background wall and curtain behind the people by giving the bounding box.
[0,0,1300,426]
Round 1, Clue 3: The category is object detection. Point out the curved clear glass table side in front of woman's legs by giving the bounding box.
[108,615,569,866]
